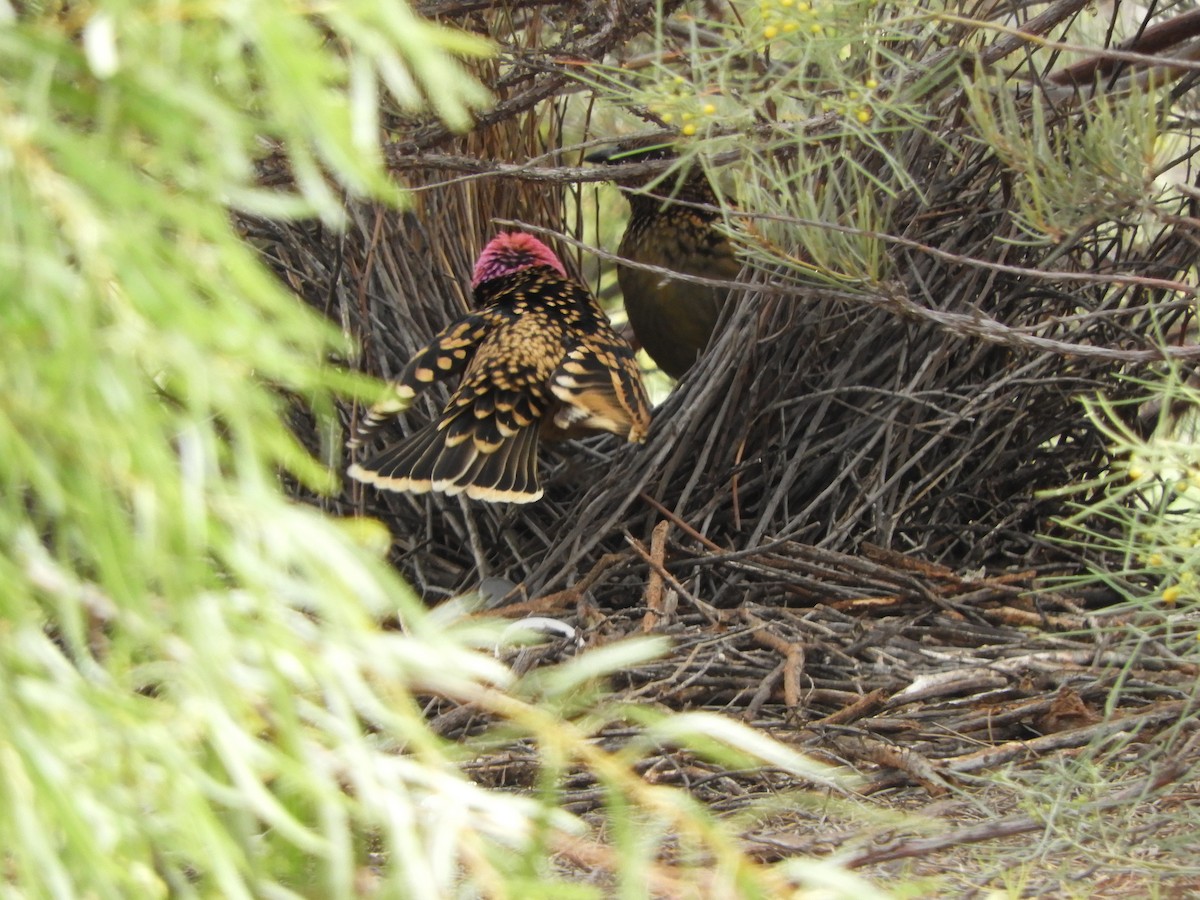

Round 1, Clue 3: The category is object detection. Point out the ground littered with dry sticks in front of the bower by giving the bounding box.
[431,545,1200,898]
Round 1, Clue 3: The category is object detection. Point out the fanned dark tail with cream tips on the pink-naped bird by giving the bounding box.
[348,409,542,503]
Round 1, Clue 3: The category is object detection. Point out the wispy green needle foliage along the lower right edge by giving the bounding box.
[1032,365,1200,895]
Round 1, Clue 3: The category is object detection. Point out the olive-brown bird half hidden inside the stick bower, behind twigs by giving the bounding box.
[587,144,740,378]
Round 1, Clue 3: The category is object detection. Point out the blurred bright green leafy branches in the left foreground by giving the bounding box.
[0,0,883,898]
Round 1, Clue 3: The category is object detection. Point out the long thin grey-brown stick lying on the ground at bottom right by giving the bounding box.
[836,733,1200,869]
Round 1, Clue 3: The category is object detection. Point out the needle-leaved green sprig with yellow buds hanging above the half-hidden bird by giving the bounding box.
[580,0,952,286]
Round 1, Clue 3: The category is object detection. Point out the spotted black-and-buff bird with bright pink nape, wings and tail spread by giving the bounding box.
[348,232,650,503]
